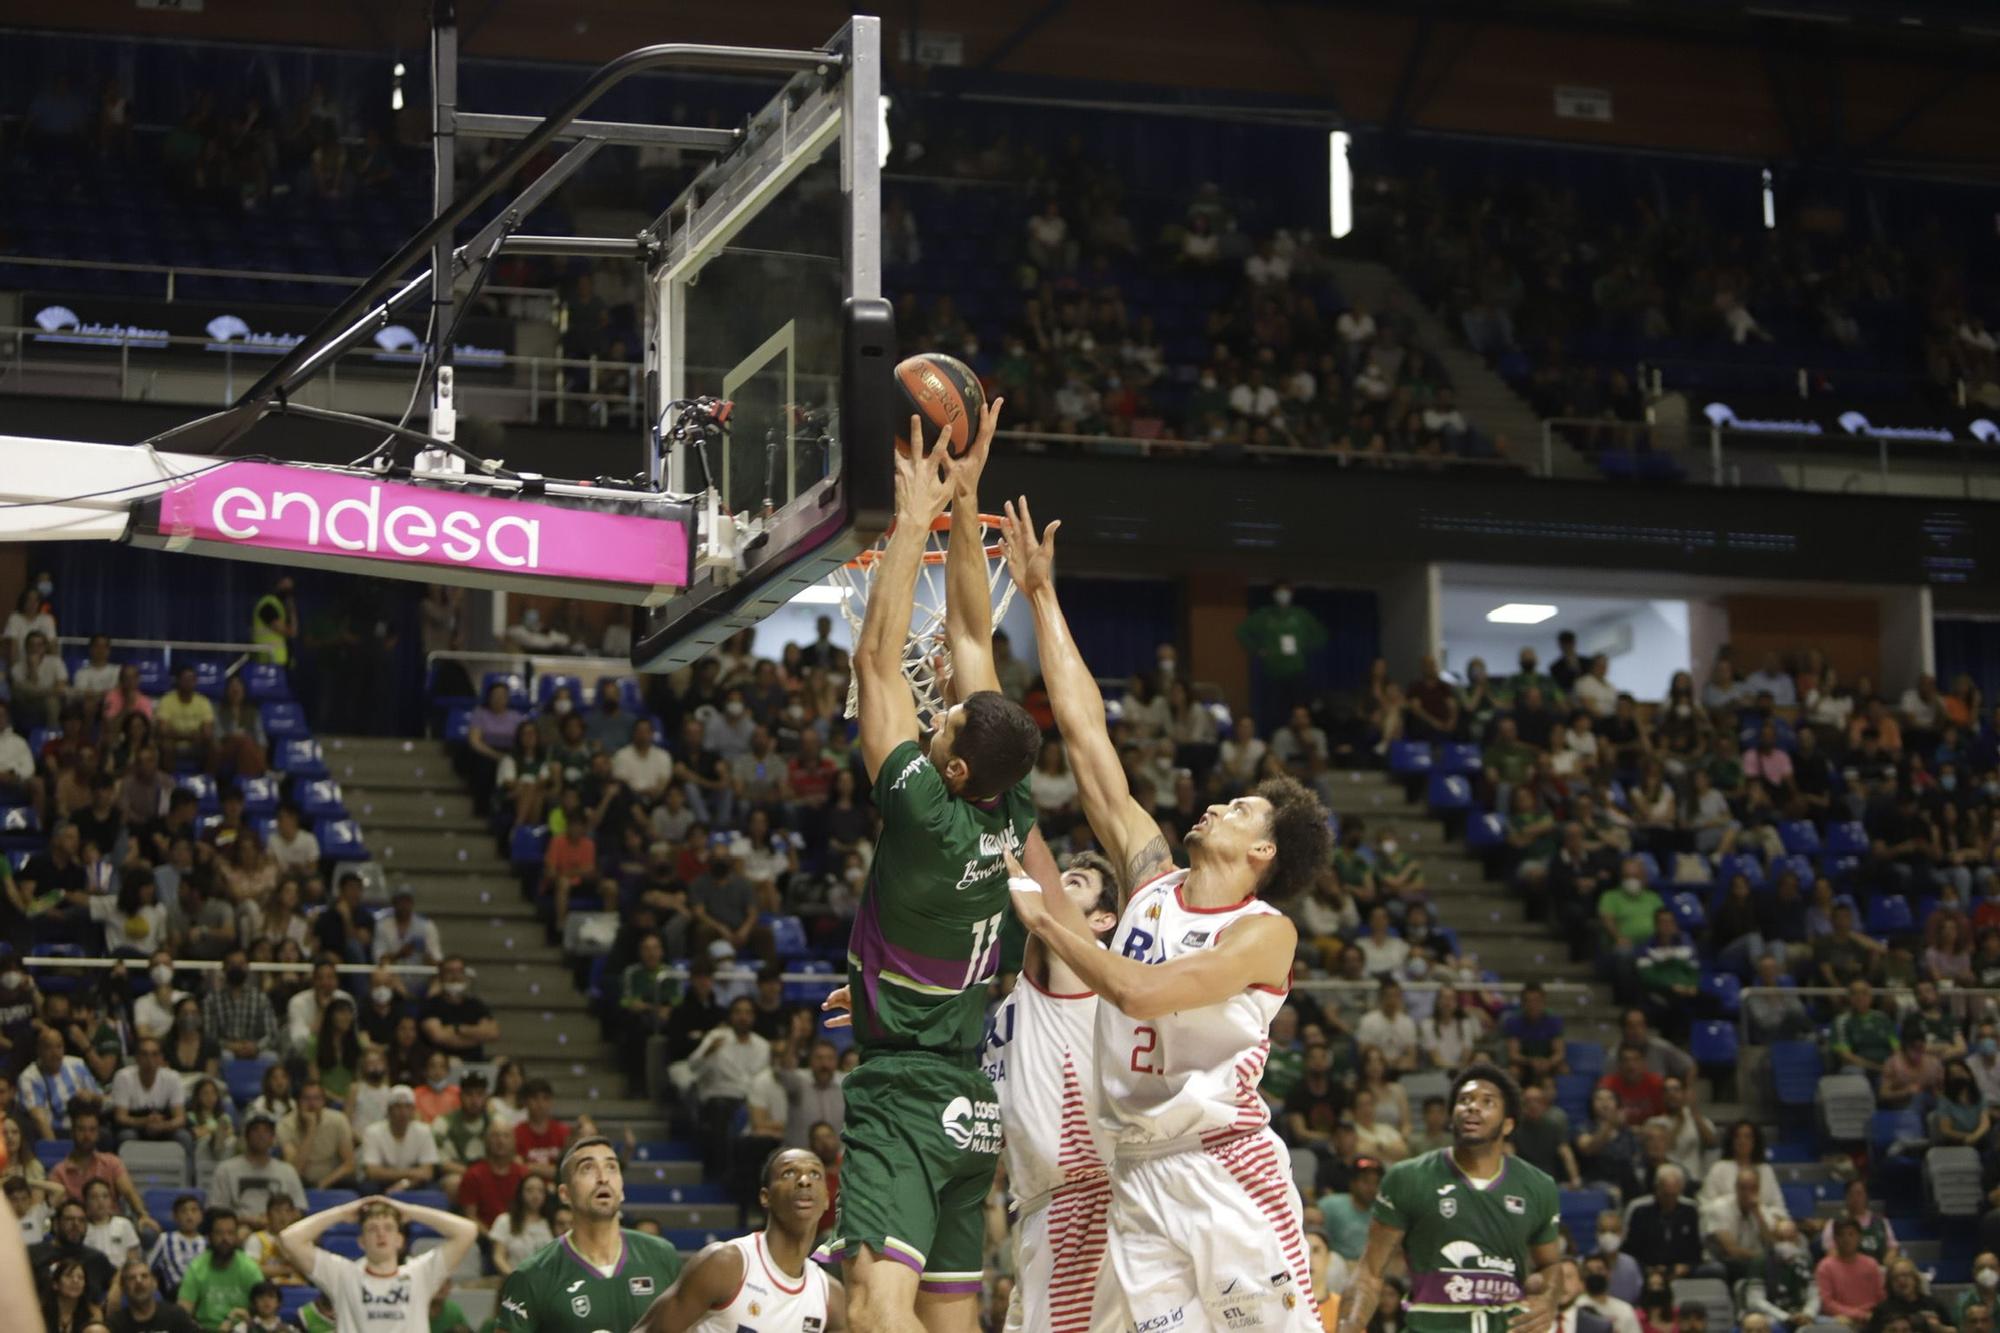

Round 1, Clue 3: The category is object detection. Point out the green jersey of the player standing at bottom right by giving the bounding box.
[1374,1149,1562,1333]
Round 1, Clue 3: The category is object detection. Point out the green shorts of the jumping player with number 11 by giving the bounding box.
[826,1051,1000,1295]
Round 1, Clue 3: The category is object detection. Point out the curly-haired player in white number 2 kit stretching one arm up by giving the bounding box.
[1004,500,1330,1333]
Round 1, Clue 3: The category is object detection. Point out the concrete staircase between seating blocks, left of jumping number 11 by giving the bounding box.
[324,737,740,1247]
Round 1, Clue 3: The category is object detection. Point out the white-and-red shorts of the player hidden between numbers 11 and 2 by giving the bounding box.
[1006,1181,1124,1333]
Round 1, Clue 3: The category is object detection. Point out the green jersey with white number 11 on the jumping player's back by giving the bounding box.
[848,741,1034,1061]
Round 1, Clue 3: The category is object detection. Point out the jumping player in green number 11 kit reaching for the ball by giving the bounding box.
[828,400,1056,1333]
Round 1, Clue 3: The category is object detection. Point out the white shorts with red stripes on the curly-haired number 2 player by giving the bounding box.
[1106,1129,1320,1333]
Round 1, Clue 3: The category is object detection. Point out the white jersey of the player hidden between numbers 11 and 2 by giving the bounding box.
[980,960,1110,1201]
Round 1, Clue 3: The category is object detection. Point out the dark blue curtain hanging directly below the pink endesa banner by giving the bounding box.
[28,542,424,737]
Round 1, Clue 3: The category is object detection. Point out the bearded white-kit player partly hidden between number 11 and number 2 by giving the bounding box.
[980,853,1118,1333]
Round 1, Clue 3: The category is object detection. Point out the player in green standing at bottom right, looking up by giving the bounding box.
[1340,1063,1562,1333]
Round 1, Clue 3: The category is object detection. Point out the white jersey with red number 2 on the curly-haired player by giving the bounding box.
[1098,871,1286,1155]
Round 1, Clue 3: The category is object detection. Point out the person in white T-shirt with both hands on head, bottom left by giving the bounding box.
[278,1195,480,1333]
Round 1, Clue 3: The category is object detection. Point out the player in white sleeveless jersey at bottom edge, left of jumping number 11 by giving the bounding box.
[632,1149,848,1333]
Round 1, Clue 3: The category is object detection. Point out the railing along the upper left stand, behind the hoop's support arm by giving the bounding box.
[0,324,644,426]
